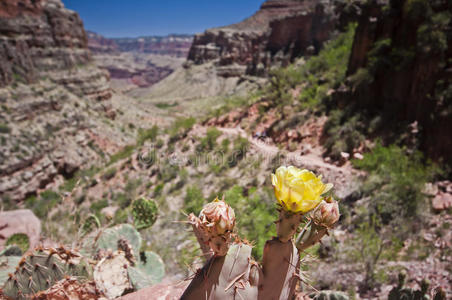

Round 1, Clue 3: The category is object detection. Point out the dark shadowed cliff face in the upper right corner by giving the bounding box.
[343,0,452,162]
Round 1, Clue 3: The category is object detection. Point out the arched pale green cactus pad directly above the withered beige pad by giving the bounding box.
[97,224,141,255]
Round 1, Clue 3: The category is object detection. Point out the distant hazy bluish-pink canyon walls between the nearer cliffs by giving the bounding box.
[88,32,192,92]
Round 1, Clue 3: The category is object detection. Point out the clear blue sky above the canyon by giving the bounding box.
[63,0,264,37]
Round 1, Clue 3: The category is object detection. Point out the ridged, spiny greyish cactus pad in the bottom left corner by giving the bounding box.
[3,247,87,300]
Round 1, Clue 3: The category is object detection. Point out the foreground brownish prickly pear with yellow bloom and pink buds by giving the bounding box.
[181,166,340,300]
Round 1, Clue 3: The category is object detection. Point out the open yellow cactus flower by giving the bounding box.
[272,166,333,214]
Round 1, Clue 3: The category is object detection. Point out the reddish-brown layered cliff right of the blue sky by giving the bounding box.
[188,0,336,76]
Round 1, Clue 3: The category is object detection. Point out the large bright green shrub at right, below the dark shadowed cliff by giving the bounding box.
[353,144,437,224]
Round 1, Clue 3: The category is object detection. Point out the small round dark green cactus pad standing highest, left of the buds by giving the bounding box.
[132,198,158,230]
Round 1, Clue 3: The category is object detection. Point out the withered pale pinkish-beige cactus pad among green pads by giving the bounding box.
[93,251,132,299]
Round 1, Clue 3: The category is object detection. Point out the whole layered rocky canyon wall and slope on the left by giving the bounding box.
[0,0,157,205]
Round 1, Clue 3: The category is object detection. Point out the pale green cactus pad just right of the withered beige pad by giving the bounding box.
[129,251,165,290]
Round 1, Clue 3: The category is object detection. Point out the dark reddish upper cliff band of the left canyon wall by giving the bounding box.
[0,0,109,98]
